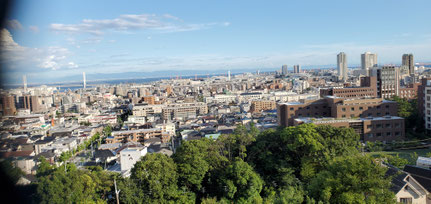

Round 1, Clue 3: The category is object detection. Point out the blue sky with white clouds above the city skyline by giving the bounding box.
[1,0,431,83]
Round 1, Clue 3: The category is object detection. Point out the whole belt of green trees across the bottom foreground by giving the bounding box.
[29,124,395,203]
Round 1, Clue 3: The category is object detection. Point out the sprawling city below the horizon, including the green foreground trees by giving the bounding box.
[0,52,431,203]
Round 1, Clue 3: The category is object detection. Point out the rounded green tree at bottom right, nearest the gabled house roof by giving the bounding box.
[308,154,395,203]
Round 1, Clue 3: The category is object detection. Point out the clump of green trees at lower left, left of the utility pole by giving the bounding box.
[35,157,114,203]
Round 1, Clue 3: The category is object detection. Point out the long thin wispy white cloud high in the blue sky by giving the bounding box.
[50,14,230,35]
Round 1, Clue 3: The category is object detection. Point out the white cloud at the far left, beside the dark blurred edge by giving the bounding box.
[0,29,77,71]
